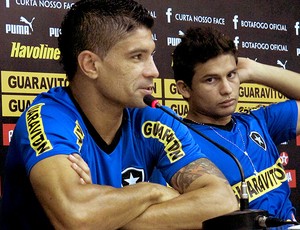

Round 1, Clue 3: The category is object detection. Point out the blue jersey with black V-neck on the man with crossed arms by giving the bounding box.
[1,87,206,229]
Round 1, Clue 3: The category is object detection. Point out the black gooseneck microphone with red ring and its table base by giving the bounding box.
[143,94,299,230]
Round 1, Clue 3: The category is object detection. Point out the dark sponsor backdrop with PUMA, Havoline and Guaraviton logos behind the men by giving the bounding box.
[0,0,300,219]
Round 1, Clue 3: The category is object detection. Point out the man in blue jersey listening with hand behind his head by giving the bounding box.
[173,27,300,220]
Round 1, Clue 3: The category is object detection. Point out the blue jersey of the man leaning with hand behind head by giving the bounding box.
[155,100,298,220]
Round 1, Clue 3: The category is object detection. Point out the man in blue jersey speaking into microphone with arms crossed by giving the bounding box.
[1,0,238,229]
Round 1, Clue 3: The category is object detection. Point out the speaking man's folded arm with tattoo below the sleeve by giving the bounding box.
[120,158,238,229]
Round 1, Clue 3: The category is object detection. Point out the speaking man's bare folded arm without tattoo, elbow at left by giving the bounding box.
[30,155,179,230]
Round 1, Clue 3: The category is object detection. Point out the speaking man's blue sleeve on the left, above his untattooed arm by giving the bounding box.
[14,103,79,173]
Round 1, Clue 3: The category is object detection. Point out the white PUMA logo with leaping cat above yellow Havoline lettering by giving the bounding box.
[5,16,35,35]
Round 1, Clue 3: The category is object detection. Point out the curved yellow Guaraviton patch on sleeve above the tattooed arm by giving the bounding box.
[142,121,185,163]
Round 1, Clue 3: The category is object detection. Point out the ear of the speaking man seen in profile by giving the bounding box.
[77,50,100,79]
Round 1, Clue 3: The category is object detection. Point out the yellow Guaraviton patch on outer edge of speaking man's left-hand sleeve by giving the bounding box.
[26,103,53,156]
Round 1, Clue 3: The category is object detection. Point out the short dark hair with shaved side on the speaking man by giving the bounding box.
[58,0,154,80]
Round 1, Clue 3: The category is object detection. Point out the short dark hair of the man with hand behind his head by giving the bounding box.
[172,27,237,87]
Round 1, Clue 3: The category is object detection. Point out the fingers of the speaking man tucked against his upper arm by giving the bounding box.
[68,153,92,184]
